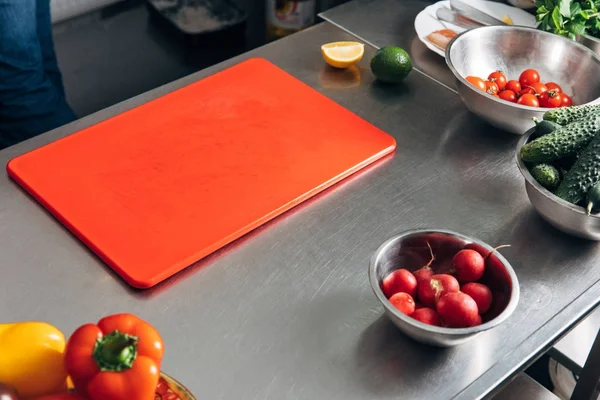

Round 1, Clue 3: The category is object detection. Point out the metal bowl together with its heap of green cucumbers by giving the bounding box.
[516,105,600,241]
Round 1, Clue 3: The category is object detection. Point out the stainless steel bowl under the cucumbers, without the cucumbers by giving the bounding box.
[516,129,600,240]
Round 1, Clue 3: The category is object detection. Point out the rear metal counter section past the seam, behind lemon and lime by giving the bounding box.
[320,0,456,90]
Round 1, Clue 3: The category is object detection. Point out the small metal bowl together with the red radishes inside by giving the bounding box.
[369,229,520,347]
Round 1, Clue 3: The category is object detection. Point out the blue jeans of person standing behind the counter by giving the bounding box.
[0,0,76,148]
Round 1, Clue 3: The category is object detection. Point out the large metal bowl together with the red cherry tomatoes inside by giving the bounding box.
[446,26,600,135]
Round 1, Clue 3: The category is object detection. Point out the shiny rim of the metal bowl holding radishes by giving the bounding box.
[369,228,521,336]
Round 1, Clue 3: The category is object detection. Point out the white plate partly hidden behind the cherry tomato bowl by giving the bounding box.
[415,0,536,57]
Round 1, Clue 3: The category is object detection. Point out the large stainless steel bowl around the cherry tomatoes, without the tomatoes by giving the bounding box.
[446,26,600,135]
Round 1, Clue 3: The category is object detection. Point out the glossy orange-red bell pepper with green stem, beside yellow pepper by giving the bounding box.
[65,314,164,400]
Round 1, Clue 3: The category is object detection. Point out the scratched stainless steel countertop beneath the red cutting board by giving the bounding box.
[0,23,600,400]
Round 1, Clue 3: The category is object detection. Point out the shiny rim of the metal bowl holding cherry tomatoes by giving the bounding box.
[445,25,600,112]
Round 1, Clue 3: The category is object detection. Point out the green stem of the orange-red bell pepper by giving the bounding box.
[93,330,138,372]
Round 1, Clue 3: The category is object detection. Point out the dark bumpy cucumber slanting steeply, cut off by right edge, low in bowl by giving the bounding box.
[555,135,600,204]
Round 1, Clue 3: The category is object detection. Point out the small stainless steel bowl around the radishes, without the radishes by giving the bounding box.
[369,229,519,347]
